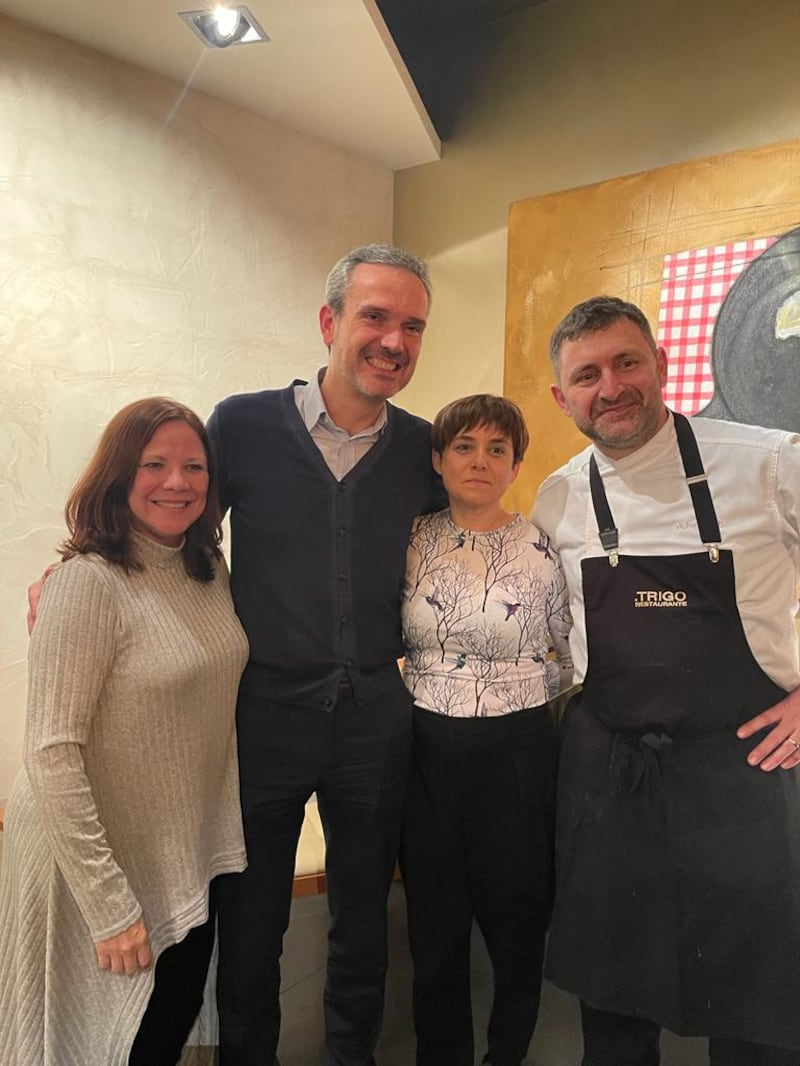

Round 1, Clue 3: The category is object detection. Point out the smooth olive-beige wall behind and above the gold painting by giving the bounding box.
[395,0,800,417]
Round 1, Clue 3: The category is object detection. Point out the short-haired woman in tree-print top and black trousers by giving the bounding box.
[402,394,572,1066]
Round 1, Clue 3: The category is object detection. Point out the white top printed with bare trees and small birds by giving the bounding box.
[403,512,571,716]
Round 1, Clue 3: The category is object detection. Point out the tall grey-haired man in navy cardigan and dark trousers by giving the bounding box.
[208,245,445,1066]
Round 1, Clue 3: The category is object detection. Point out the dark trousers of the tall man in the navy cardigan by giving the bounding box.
[217,675,411,1066]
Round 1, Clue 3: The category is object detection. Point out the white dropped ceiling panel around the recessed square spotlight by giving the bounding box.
[0,0,441,171]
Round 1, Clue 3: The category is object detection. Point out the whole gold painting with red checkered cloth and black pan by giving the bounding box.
[505,141,800,511]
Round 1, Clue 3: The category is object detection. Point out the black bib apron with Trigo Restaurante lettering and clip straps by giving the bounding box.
[546,415,800,1049]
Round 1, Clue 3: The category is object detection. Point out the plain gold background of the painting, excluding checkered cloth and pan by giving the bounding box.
[505,141,800,503]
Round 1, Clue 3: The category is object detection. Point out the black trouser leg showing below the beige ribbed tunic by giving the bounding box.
[128,882,215,1066]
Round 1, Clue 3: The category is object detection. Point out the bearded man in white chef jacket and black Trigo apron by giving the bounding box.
[533,296,800,1066]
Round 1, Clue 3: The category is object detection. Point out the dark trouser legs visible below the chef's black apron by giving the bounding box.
[580,1002,800,1066]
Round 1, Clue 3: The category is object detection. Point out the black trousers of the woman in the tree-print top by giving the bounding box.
[402,708,557,1066]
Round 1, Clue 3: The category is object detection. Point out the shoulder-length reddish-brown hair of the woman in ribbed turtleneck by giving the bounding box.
[60,397,222,581]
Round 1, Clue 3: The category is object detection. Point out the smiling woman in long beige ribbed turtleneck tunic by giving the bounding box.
[0,398,247,1066]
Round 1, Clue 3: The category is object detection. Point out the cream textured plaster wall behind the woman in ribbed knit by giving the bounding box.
[0,18,393,797]
